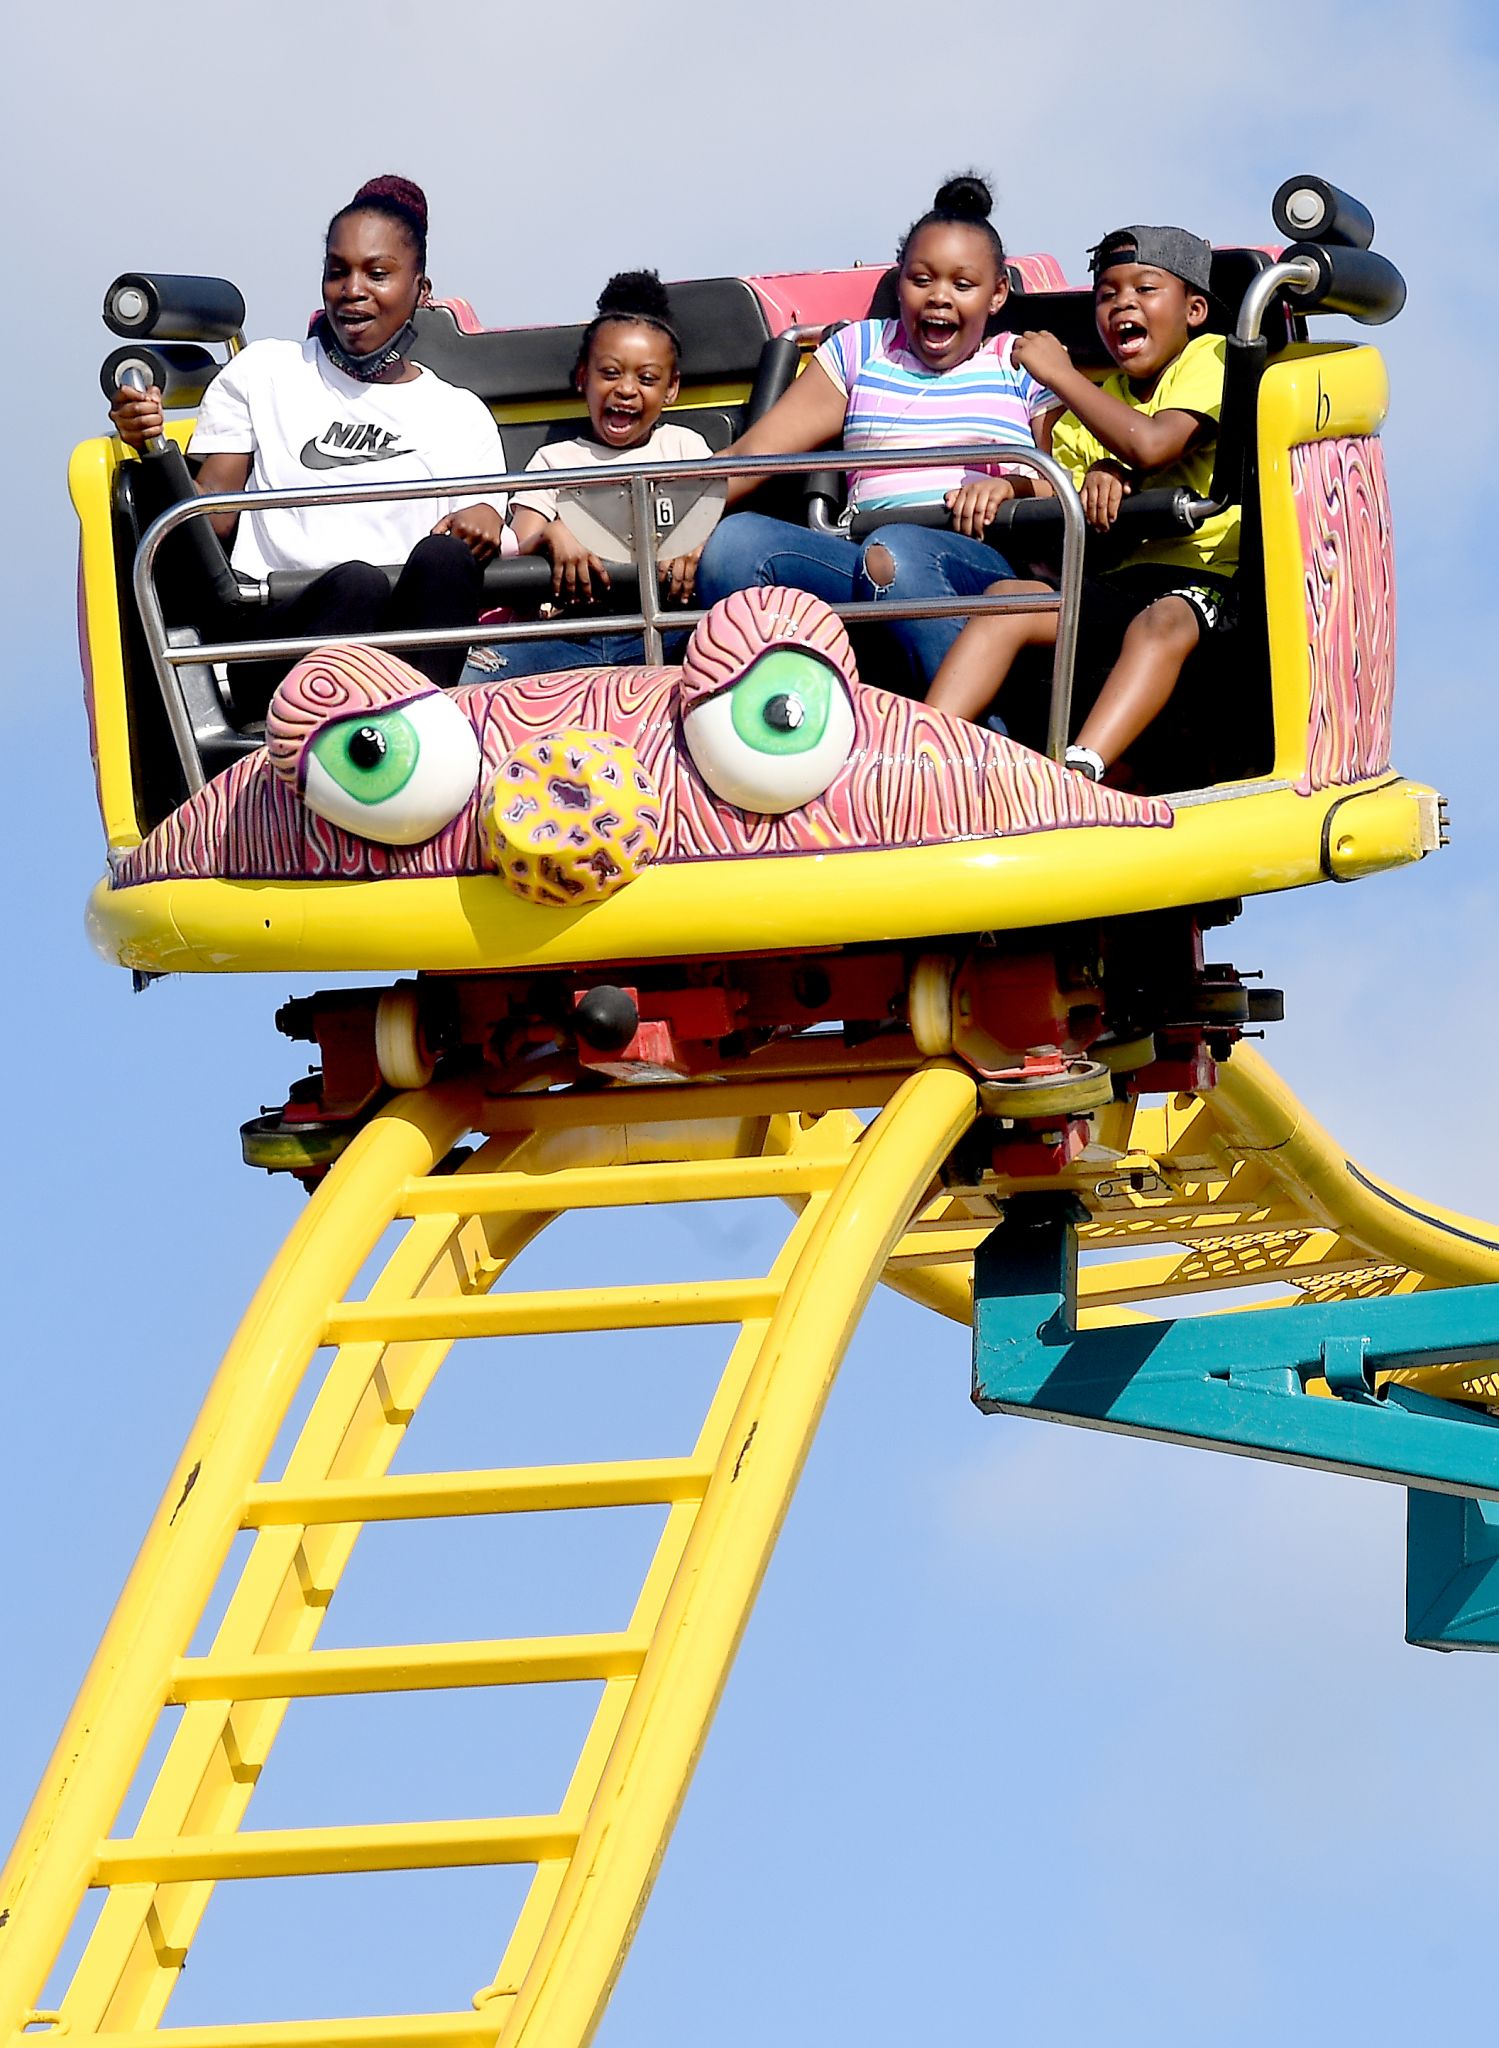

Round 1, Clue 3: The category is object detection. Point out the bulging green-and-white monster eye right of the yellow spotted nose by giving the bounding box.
[682,647,854,813]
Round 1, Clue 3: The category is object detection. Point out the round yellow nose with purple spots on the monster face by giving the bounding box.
[479,727,661,909]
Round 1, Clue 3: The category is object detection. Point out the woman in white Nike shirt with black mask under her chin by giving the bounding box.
[109,176,506,696]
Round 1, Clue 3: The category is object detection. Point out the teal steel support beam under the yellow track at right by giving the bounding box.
[973,1194,1499,1649]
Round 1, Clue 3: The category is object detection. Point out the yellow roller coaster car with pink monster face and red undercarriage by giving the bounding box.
[70,178,1444,1171]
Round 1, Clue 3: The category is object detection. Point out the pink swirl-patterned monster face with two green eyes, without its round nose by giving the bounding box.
[115,590,1171,889]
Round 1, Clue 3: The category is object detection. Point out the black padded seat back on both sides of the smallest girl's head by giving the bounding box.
[412,276,770,406]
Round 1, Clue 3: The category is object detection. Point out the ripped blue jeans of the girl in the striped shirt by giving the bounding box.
[698,512,1014,688]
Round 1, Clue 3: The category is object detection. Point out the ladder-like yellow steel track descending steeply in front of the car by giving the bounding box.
[0,1065,975,2048]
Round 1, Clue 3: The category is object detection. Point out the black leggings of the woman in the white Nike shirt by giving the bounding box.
[203,532,483,719]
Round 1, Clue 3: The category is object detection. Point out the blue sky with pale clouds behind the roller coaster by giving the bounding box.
[0,0,1499,2048]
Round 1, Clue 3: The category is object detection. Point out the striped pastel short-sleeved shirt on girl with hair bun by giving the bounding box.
[817,319,1061,512]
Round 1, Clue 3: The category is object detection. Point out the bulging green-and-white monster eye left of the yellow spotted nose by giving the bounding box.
[303,690,479,846]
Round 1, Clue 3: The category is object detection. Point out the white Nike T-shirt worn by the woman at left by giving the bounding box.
[188,336,506,575]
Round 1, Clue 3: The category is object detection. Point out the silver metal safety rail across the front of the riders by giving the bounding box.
[131,442,1085,793]
